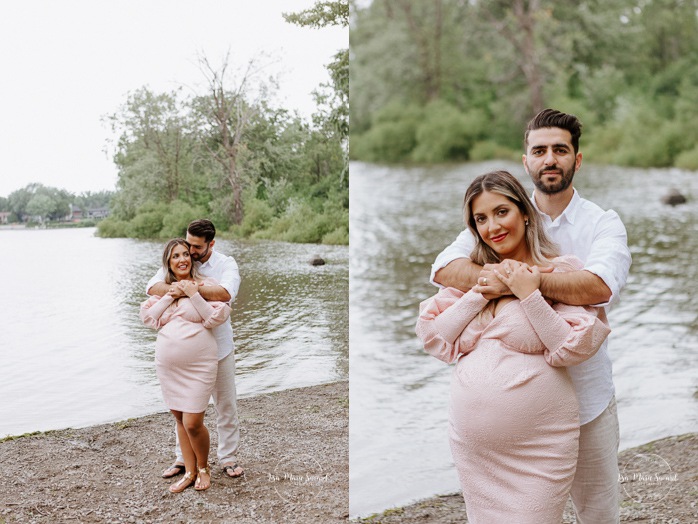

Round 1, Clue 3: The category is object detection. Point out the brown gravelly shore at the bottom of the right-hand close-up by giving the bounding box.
[354,433,698,524]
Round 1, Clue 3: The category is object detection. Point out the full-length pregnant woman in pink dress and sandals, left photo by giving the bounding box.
[140,238,230,493]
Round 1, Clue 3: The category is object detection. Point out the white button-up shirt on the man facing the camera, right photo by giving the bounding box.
[431,189,631,424]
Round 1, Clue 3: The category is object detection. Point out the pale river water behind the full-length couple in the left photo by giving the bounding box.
[0,228,349,438]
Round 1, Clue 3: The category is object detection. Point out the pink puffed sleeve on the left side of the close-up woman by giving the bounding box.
[415,288,488,364]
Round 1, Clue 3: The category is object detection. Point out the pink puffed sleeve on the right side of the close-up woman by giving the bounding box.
[521,290,611,367]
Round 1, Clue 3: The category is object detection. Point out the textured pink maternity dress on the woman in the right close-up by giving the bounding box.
[417,257,610,524]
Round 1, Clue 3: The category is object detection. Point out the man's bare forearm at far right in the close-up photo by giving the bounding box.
[540,270,611,306]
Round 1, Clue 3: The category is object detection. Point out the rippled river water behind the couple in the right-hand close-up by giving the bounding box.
[349,162,698,516]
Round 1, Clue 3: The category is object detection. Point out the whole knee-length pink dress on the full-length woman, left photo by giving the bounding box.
[140,279,230,413]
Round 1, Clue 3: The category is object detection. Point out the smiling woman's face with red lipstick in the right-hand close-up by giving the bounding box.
[470,191,529,260]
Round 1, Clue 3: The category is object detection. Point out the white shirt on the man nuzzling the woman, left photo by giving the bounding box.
[145,250,240,360]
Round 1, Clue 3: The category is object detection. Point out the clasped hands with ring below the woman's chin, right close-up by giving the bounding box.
[472,259,553,300]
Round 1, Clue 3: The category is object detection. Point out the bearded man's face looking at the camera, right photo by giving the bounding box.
[523,127,582,195]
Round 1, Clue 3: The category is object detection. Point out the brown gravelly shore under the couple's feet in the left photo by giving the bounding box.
[0,381,349,524]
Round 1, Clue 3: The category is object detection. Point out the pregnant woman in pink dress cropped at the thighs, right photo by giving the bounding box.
[416,171,610,524]
